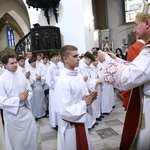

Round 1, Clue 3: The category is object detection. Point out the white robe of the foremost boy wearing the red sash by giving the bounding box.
[54,68,92,150]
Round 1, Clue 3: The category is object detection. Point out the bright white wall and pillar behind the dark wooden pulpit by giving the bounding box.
[24,0,95,53]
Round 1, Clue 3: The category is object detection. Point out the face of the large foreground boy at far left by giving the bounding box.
[4,58,18,72]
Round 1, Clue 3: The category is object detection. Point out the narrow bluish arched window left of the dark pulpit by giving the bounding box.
[7,26,15,47]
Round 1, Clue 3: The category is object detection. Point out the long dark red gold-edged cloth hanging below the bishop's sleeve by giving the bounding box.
[120,87,142,150]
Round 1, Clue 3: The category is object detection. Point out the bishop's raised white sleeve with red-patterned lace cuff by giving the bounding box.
[100,48,150,90]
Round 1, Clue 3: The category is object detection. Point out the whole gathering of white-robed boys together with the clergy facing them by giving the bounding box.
[0,2,150,150]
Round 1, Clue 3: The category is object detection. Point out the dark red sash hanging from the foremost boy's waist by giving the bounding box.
[75,123,88,150]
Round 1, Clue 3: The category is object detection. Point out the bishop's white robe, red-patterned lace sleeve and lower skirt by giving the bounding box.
[100,47,150,150]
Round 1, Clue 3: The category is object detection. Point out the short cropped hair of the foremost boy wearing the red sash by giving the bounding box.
[60,45,78,61]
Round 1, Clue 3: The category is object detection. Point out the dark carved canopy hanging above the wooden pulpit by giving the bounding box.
[26,0,60,24]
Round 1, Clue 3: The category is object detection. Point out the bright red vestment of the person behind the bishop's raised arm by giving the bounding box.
[122,41,144,110]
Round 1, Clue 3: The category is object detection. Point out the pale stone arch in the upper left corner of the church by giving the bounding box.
[0,0,30,38]
